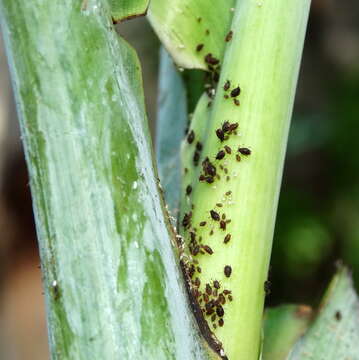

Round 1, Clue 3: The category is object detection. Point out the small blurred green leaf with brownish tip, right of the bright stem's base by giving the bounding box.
[262,305,312,360]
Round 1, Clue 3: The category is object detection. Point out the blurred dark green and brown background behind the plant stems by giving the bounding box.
[0,0,359,360]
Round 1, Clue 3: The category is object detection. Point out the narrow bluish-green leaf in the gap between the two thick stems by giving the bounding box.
[156,48,187,216]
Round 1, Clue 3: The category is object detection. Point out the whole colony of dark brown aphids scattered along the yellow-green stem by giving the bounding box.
[181,17,251,340]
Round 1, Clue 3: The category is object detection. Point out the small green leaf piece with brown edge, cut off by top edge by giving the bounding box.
[109,0,149,21]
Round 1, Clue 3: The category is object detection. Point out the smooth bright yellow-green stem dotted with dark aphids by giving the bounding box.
[183,0,310,360]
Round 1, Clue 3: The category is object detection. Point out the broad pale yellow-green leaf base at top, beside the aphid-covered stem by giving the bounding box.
[148,0,236,69]
